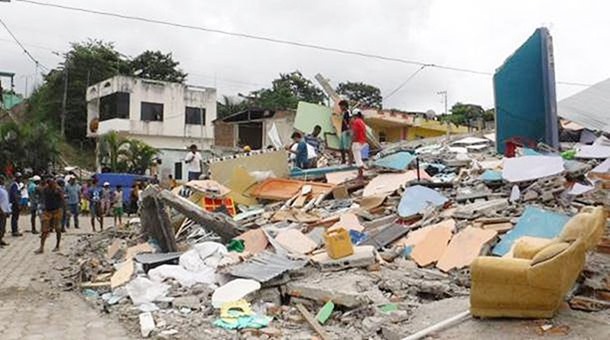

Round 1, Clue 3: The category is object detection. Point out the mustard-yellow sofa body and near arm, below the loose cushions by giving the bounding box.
[470,239,586,318]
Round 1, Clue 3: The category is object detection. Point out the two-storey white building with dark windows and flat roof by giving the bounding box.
[86,76,216,179]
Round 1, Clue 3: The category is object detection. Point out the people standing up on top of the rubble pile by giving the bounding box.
[287,100,367,179]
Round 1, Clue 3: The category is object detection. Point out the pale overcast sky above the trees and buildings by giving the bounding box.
[0,0,610,113]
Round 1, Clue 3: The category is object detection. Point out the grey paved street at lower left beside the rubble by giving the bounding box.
[0,216,130,340]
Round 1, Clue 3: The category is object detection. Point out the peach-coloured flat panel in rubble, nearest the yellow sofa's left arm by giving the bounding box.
[436,227,497,272]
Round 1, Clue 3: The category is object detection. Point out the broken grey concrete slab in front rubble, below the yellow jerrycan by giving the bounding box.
[286,271,389,308]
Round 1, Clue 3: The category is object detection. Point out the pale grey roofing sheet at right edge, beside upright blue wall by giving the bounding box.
[557,79,610,132]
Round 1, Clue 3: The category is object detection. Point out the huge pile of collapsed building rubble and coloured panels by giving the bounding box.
[66,137,610,339]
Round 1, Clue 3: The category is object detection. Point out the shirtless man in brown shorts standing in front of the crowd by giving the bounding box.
[34,178,65,254]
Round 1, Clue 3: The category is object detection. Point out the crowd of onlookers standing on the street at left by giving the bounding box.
[0,173,141,254]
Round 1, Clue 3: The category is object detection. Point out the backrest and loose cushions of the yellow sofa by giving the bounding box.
[513,206,608,259]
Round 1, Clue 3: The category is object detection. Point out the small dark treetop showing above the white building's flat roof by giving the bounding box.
[129,51,187,83]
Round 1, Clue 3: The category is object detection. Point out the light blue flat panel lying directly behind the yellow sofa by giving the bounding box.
[492,206,570,256]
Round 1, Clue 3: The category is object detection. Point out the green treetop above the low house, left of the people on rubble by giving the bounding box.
[251,71,326,110]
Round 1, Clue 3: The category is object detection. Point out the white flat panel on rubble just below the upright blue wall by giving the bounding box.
[502,156,564,183]
